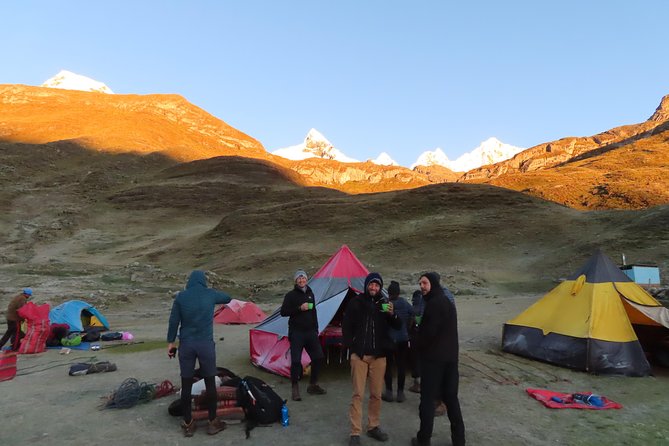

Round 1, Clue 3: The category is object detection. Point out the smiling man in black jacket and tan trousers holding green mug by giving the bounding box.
[342,273,402,446]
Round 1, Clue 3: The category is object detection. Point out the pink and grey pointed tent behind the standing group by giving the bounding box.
[249,245,369,377]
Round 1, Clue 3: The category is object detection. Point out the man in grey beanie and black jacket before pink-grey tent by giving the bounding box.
[281,270,326,401]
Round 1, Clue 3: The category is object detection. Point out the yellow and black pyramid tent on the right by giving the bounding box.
[502,250,669,376]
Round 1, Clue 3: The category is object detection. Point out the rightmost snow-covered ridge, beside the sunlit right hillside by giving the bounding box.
[411,138,525,172]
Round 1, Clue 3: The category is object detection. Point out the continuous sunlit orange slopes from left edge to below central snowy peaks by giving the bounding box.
[0,85,429,193]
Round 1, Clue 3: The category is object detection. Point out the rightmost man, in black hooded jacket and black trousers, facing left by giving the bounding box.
[411,272,465,446]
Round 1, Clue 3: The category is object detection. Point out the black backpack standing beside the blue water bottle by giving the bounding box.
[237,376,286,438]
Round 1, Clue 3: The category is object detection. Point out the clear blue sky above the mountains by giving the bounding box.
[0,0,669,165]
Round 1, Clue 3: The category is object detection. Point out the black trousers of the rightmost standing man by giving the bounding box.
[416,360,465,446]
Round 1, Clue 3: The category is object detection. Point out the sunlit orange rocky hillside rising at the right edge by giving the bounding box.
[459,95,669,209]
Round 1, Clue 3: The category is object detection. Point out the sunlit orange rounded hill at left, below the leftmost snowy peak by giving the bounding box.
[0,85,266,160]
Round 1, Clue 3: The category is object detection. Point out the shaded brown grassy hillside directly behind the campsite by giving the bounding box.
[0,142,669,300]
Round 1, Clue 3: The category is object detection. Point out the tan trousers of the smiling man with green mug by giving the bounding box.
[349,353,386,435]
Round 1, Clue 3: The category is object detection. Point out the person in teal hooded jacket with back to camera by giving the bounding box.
[167,270,231,437]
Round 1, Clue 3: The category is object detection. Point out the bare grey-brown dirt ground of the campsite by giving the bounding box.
[0,295,669,446]
